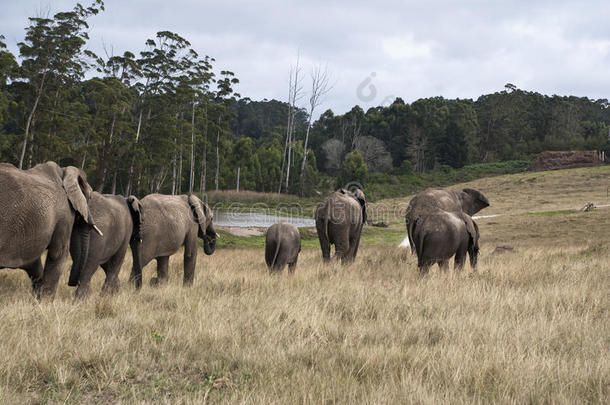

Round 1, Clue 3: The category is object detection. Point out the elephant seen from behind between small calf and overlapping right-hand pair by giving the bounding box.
[315,189,366,264]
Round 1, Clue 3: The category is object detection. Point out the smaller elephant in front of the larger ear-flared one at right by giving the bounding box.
[413,210,479,274]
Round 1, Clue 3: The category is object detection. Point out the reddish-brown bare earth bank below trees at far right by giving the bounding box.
[528,150,606,172]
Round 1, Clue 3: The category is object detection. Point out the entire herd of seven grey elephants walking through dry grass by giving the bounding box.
[0,162,489,299]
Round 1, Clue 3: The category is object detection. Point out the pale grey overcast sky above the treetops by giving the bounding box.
[0,0,610,115]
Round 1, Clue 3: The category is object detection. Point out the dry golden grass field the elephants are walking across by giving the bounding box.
[0,169,610,404]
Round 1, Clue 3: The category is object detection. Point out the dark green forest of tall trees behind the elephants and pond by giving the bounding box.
[0,0,610,196]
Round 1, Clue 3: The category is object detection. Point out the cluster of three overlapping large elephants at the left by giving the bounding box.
[0,162,217,299]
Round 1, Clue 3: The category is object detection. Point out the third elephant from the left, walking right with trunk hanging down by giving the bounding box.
[129,194,218,289]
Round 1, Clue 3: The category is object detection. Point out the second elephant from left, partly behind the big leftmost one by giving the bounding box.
[68,191,142,297]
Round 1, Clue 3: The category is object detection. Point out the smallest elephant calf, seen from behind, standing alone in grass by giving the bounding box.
[265,222,301,273]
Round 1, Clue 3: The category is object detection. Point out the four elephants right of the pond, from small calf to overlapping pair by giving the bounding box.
[265,188,489,274]
